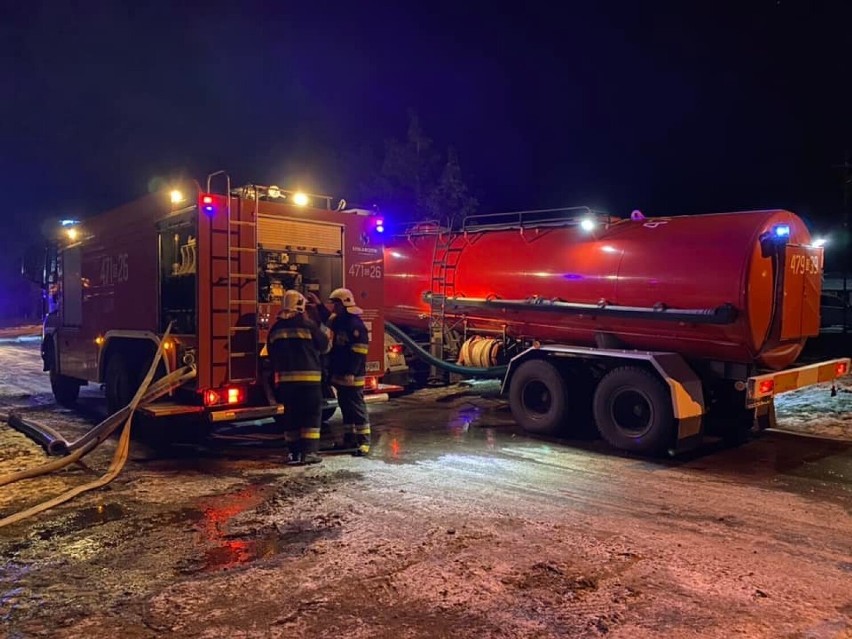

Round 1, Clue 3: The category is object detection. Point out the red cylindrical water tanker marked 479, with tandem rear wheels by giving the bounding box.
[385,208,850,453]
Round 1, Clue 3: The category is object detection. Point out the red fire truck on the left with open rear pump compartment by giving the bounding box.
[29,172,395,422]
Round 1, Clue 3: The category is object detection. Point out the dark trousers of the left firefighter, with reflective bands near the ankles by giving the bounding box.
[275,382,323,455]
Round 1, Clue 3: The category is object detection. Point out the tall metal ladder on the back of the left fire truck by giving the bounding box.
[207,173,260,382]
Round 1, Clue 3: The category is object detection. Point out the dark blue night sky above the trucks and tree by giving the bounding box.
[0,0,852,296]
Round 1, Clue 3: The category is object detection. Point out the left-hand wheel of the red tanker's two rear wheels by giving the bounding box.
[509,359,568,435]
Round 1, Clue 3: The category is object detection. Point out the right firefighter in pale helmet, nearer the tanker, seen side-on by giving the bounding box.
[329,288,370,456]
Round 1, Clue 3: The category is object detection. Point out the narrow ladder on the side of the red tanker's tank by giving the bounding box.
[429,230,464,379]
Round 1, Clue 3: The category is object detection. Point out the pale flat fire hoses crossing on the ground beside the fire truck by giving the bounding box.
[0,324,195,528]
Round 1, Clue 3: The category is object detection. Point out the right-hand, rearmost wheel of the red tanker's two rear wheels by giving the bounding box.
[594,366,675,454]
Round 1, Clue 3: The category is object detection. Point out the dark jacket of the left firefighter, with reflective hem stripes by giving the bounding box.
[267,313,331,384]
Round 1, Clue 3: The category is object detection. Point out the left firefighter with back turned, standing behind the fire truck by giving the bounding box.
[267,290,331,464]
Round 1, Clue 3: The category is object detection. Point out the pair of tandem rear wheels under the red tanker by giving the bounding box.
[509,359,675,454]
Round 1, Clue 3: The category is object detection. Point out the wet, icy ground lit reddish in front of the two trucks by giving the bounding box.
[0,344,852,639]
